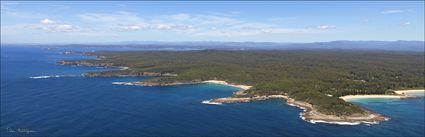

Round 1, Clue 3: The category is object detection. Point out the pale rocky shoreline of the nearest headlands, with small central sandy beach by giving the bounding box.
[117,80,389,125]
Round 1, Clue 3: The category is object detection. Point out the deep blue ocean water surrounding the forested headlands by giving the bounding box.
[0,46,425,136]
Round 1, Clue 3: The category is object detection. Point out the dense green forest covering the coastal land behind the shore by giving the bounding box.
[61,50,425,115]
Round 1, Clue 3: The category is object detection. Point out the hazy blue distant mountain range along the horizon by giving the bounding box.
[2,40,425,52]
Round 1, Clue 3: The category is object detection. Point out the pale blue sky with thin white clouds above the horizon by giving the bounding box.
[1,1,424,43]
